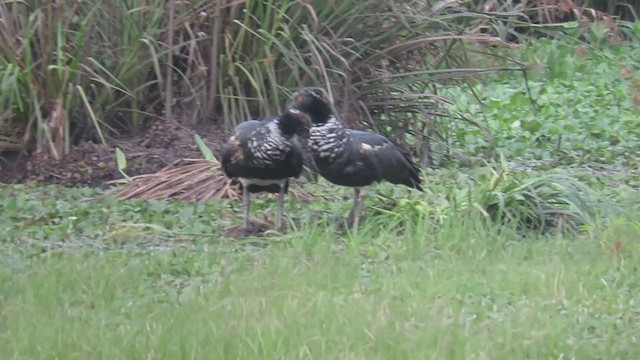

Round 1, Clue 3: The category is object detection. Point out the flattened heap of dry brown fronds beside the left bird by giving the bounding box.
[110,159,314,201]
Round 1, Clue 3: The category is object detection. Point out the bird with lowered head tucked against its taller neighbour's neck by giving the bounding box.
[221,109,305,234]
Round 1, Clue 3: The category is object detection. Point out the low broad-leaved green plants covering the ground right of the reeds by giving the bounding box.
[441,40,640,167]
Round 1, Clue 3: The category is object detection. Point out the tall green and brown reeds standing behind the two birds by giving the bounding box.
[0,0,638,183]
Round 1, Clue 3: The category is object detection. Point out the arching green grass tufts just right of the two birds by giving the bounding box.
[371,158,612,233]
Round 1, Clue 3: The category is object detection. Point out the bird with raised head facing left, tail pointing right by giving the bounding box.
[289,89,423,229]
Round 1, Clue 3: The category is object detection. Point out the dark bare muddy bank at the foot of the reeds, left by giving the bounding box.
[0,121,228,187]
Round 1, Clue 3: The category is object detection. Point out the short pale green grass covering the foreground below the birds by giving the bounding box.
[0,186,640,359]
